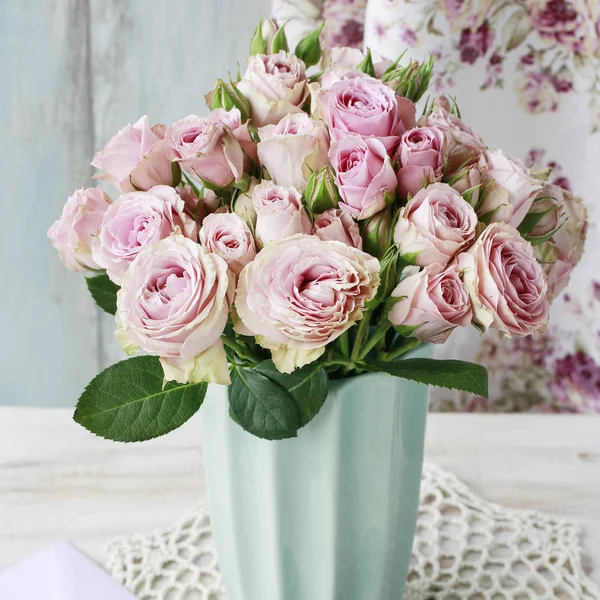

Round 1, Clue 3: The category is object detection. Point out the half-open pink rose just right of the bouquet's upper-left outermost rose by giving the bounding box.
[165,115,245,188]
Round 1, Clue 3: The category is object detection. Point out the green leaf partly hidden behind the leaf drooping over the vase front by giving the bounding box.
[255,360,327,427]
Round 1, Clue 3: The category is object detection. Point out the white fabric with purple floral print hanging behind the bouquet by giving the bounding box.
[278,0,600,412]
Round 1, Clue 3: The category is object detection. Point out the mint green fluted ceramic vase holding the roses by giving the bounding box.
[202,348,429,600]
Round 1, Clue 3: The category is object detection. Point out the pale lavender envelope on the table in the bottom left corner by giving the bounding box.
[0,542,136,600]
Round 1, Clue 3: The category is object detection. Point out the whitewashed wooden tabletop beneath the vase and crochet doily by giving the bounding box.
[0,408,600,583]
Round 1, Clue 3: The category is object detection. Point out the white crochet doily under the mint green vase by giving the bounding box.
[107,464,600,600]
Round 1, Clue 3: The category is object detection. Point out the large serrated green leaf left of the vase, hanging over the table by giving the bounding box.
[73,356,208,442]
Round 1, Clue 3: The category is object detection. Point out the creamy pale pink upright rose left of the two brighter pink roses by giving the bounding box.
[258,113,329,192]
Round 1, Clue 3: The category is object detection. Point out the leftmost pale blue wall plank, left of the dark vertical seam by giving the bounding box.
[0,0,100,405]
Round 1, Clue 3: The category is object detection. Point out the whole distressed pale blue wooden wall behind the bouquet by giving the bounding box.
[0,0,269,405]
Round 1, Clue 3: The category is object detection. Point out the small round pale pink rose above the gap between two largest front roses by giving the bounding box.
[200,212,256,275]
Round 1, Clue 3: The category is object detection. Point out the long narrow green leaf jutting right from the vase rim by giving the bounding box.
[358,358,488,398]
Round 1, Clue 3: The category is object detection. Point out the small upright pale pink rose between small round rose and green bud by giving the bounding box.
[252,181,312,246]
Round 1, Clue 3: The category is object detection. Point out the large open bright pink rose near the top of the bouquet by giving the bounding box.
[326,77,416,154]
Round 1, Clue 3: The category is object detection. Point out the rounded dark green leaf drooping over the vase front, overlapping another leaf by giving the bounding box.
[228,367,300,440]
